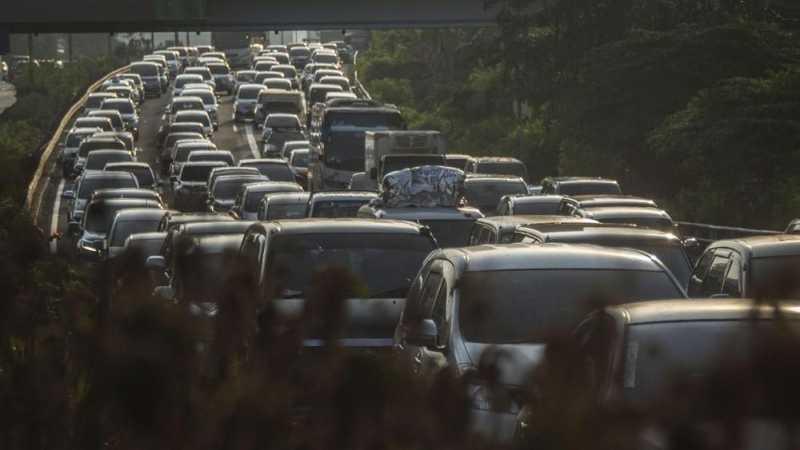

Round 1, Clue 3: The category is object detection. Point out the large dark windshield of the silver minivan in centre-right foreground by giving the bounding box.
[459,269,683,344]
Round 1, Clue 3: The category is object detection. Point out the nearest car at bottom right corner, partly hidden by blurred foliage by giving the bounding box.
[514,299,800,449]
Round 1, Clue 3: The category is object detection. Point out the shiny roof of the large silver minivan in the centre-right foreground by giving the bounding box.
[441,244,665,272]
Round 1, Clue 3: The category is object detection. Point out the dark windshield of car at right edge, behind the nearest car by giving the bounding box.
[749,255,800,299]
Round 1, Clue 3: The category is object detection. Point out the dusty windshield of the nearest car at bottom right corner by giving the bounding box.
[620,320,800,404]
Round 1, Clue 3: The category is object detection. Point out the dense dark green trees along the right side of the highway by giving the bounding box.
[359,0,800,228]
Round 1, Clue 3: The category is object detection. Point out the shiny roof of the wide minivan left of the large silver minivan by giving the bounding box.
[254,218,424,235]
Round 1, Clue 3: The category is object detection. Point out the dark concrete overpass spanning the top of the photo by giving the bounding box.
[0,0,496,34]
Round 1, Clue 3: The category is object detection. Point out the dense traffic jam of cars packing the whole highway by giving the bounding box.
[56,38,800,442]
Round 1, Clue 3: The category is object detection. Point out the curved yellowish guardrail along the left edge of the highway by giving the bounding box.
[25,66,128,223]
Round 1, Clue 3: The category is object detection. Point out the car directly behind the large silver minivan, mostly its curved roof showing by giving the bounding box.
[512,224,692,289]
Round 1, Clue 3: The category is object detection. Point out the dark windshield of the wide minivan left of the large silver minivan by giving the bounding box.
[267,233,434,298]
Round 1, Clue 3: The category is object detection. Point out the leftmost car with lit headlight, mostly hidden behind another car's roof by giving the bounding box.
[76,198,162,260]
